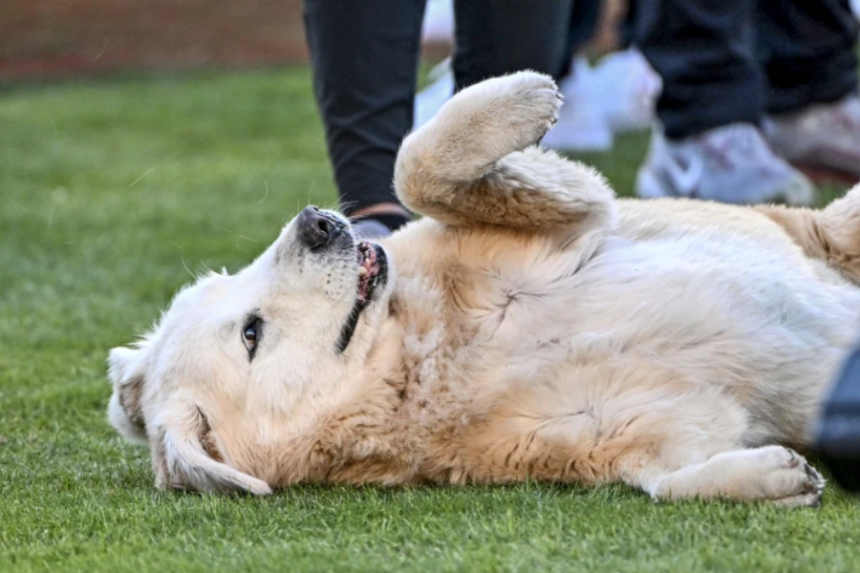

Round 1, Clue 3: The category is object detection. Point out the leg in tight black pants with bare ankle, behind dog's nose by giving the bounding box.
[304,0,424,226]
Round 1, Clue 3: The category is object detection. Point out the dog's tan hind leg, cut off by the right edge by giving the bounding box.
[757,184,860,285]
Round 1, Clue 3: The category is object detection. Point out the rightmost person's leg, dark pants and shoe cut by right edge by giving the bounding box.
[757,0,860,182]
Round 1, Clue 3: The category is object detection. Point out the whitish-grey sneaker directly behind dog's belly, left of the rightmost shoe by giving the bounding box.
[636,123,815,205]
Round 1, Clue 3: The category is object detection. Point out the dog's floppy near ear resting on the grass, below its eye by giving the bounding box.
[152,400,272,495]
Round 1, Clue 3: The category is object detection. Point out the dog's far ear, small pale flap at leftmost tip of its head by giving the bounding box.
[108,347,148,444]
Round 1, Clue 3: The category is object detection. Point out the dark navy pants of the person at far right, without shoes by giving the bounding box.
[633,0,857,138]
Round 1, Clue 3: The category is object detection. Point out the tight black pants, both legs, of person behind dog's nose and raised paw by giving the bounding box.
[304,0,573,214]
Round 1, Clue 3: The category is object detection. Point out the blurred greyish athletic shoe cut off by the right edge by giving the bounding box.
[765,94,860,183]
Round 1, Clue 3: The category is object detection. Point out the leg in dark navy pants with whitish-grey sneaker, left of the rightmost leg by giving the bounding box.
[634,0,814,205]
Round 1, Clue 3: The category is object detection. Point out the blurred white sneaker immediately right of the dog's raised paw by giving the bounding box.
[541,58,613,152]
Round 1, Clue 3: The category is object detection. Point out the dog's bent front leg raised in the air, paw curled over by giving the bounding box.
[395,72,615,235]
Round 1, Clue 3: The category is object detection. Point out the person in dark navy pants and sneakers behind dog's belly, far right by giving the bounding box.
[633,0,860,205]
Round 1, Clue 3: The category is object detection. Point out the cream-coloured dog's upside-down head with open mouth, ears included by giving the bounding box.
[108,207,393,493]
